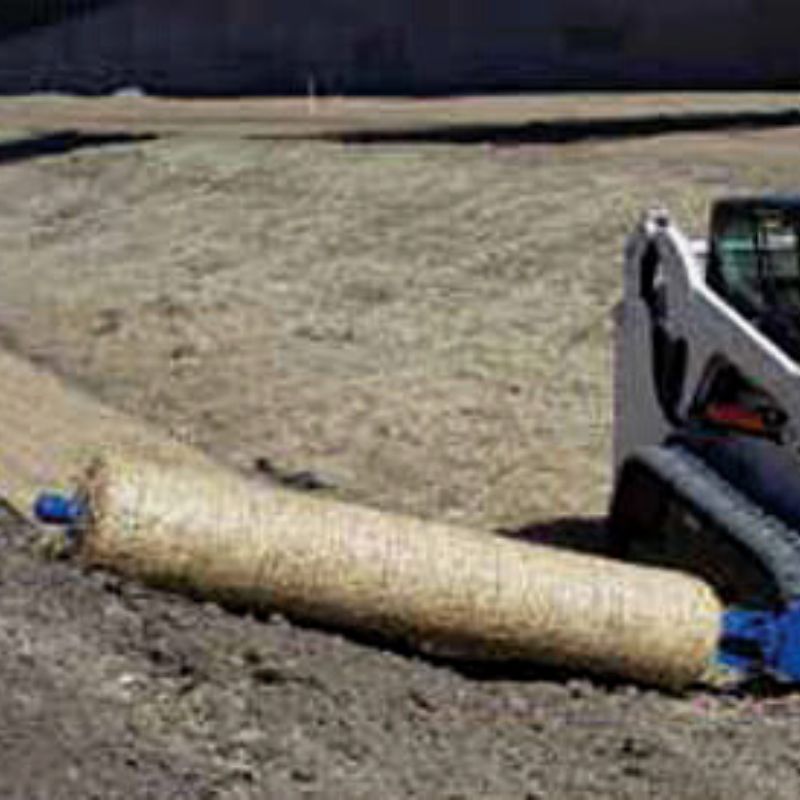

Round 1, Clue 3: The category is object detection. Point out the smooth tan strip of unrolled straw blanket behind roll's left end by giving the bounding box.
[0,349,208,516]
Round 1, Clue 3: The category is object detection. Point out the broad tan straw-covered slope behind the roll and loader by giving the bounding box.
[0,120,800,526]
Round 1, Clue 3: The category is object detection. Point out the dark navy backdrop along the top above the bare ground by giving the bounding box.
[0,0,800,96]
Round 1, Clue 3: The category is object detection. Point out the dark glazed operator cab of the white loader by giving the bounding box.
[708,196,800,360]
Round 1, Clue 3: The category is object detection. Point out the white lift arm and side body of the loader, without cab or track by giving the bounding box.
[614,211,800,521]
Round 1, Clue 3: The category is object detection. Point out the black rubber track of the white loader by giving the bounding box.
[609,446,800,608]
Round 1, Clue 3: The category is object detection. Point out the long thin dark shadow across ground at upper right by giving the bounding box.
[321,108,800,145]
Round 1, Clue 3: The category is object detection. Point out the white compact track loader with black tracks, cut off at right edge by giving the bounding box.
[609,196,800,610]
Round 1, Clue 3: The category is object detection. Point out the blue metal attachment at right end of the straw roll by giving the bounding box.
[717,600,800,683]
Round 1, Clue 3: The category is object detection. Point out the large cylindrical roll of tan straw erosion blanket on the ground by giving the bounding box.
[82,457,721,687]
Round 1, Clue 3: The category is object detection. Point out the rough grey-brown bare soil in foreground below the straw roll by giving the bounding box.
[6,506,800,800]
